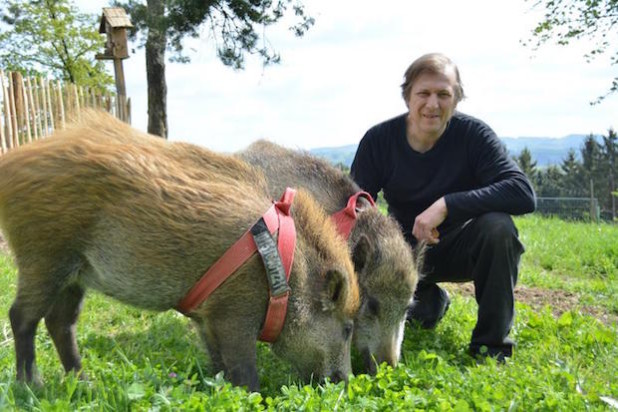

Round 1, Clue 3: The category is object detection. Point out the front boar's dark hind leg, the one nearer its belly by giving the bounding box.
[45,284,85,378]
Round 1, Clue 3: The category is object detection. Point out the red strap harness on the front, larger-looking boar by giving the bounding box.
[176,188,296,343]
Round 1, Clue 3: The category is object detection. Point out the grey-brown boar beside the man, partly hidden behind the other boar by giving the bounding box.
[237,141,418,373]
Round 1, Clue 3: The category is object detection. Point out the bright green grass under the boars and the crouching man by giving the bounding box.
[0,215,618,411]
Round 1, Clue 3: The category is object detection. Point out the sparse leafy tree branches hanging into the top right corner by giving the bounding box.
[531,0,618,104]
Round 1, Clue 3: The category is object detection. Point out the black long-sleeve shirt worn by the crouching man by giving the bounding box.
[351,112,536,241]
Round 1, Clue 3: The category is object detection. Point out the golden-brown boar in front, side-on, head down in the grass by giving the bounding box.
[0,112,359,390]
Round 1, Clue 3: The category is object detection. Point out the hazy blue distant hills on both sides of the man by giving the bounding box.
[309,134,587,167]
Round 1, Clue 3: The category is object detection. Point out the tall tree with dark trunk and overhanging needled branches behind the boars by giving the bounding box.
[115,0,314,138]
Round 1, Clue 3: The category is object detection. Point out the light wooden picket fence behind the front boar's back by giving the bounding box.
[0,70,131,155]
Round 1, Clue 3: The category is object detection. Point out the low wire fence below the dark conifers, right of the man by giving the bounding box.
[536,197,601,222]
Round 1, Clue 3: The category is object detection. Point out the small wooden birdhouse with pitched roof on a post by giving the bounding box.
[96,7,133,60]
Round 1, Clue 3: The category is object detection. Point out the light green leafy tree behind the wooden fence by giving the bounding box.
[0,0,113,89]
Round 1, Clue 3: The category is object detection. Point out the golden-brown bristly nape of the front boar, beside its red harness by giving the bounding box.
[292,189,360,316]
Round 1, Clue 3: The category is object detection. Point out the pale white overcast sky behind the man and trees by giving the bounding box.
[76,0,618,152]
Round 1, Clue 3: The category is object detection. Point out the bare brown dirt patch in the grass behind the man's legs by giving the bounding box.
[446,283,618,325]
